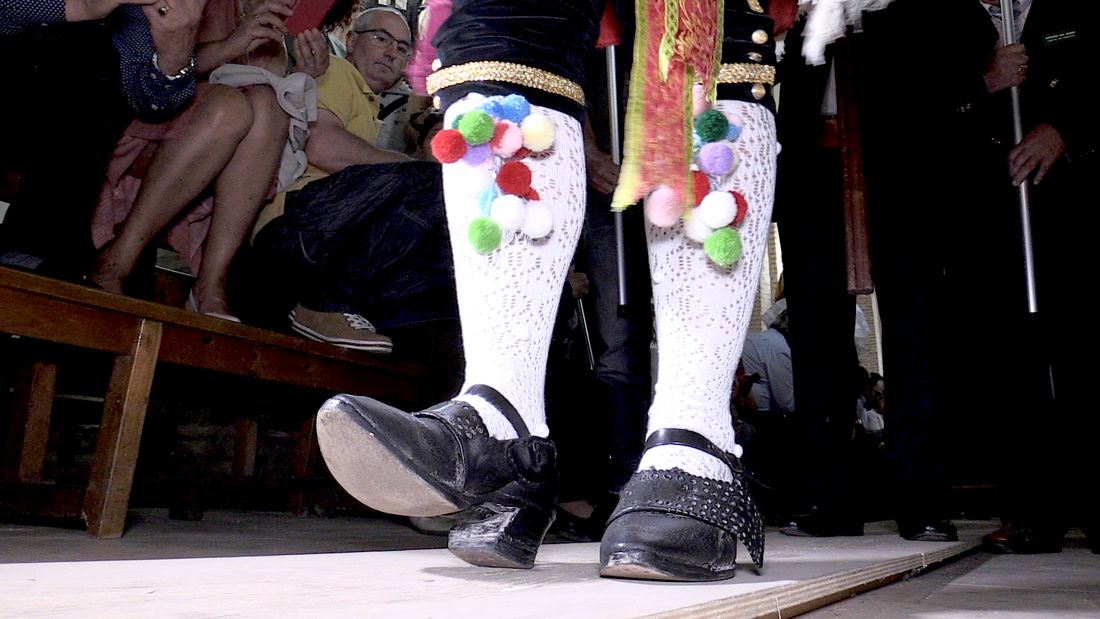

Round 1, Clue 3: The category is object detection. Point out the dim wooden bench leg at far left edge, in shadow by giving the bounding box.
[4,362,57,483]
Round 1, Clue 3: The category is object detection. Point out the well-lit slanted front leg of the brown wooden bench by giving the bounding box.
[84,320,163,539]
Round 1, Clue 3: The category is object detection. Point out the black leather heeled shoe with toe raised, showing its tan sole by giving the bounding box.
[317,385,558,567]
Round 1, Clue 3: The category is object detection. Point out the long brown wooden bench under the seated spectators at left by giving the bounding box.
[0,267,449,538]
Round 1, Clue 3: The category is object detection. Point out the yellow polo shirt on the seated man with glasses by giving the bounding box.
[252,56,380,239]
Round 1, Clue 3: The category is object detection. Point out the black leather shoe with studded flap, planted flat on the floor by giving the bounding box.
[600,429,763,582]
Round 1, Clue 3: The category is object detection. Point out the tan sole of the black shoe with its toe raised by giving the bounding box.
[317,398,465,517]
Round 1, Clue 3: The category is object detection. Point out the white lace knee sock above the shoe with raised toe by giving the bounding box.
[443,95,585,439]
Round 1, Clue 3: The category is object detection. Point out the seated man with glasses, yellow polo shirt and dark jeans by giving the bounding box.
[253,7,458,353]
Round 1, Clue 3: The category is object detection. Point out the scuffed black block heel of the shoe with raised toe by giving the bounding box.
[447,504,554,570]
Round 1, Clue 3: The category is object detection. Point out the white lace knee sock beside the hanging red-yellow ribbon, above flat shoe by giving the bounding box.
[639,101,777,482]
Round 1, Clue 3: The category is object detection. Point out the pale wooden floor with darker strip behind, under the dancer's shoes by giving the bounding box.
[0,510,996,619]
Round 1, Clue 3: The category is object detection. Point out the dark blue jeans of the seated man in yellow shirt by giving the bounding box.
[253,162,458,330]
